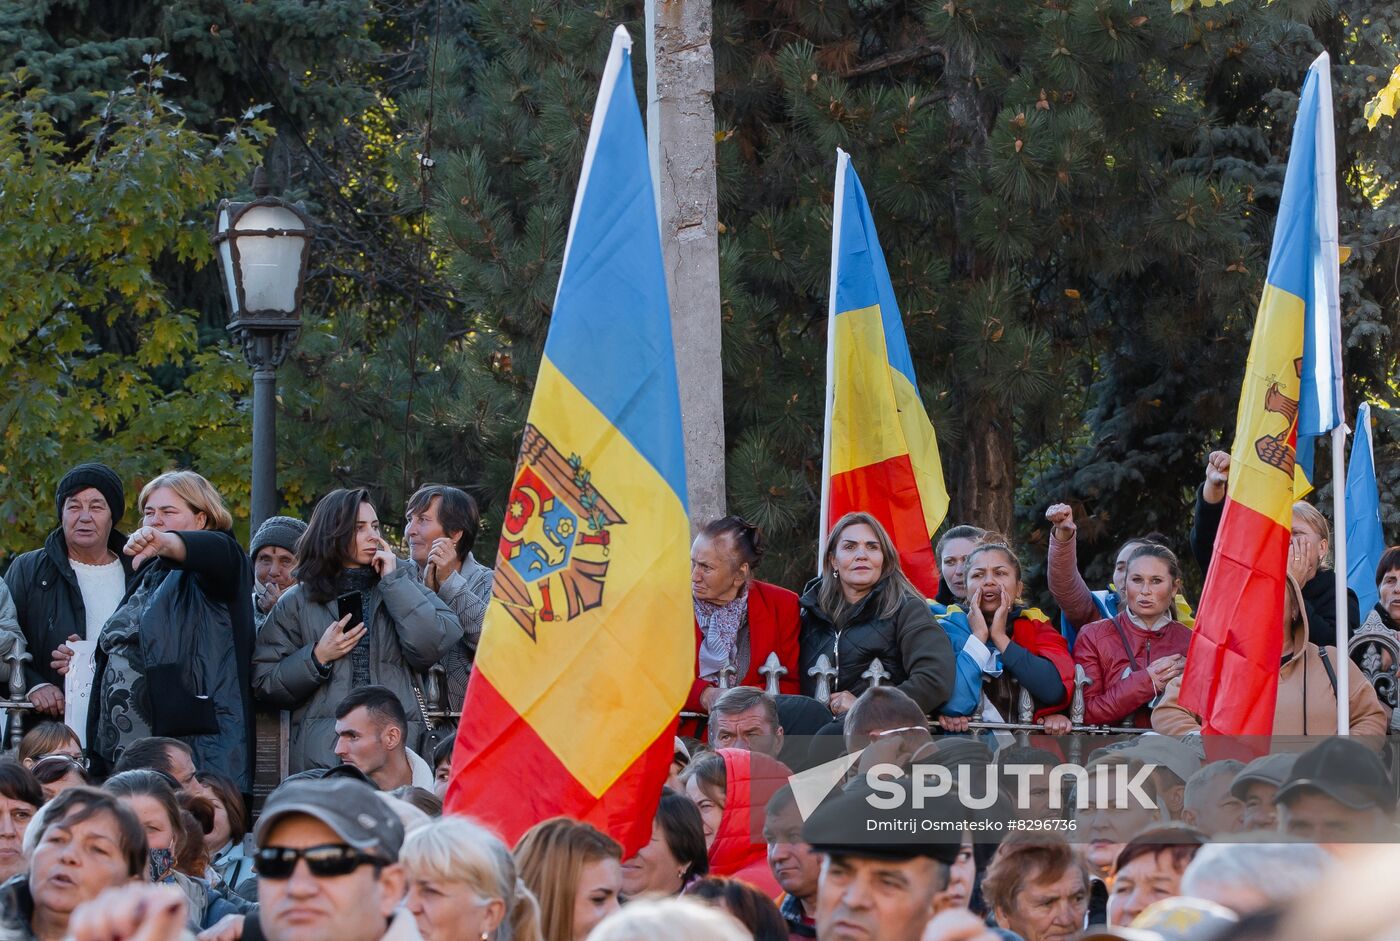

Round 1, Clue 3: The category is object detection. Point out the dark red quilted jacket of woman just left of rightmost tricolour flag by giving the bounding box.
[1074,611,1191,728]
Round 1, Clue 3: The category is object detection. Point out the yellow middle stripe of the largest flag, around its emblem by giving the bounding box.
[477,358,694,797]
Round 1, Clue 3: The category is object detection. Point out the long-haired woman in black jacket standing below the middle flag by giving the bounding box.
[799,513,953,716]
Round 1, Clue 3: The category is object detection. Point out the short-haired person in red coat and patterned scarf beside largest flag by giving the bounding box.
[686,517,798,713]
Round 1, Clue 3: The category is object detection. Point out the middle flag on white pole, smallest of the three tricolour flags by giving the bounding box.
[818,150,948,598]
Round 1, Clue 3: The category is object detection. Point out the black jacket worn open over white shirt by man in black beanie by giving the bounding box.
[4,527,132,689]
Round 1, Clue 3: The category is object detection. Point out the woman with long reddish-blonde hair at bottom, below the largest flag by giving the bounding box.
[515,816,622,941]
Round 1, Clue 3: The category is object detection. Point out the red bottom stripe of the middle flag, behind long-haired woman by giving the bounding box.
[826,454,938,598]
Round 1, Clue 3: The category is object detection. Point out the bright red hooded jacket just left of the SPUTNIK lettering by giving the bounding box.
[710,750,792,899]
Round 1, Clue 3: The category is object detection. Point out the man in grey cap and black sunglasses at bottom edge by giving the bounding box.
[253,777,421,941]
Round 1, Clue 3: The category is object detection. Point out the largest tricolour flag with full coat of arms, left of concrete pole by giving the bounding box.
[447,28,696,854]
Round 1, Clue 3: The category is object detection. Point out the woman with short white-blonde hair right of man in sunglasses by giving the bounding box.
[399,816,540,941]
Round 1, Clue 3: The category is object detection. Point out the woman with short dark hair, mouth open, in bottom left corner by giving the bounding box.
[0,787,146,941]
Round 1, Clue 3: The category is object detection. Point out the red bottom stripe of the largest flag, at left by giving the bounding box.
[444,669,676,858]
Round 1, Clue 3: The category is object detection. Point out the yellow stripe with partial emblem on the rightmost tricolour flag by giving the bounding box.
[1229,284,1305,529]
